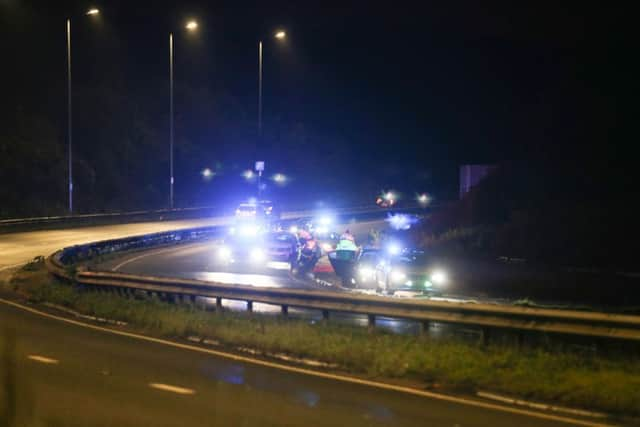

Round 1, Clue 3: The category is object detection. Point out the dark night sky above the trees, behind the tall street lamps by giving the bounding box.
[0,0,636,206]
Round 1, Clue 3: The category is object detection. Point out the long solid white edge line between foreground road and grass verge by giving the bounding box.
[0,298,611,427]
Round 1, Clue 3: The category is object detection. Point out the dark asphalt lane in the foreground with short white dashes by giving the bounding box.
[0,302,592,427]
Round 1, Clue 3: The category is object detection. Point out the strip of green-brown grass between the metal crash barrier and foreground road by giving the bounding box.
[4,265,640,416]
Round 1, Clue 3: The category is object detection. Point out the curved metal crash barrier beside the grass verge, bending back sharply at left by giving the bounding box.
[42,221,640,341]
